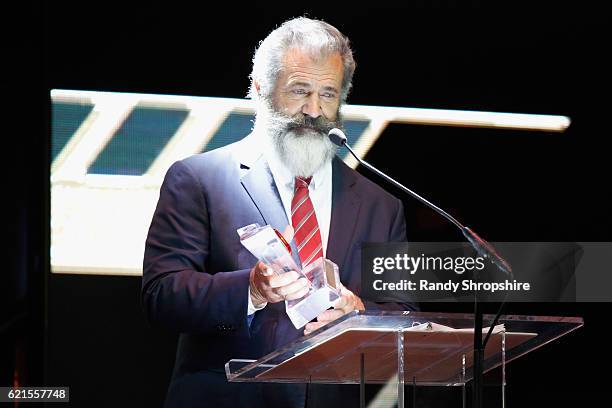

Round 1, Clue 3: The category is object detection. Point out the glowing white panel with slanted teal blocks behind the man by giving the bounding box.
[51,90,569,275]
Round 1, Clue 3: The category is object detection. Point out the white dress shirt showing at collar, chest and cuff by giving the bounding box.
[248,138,332,315]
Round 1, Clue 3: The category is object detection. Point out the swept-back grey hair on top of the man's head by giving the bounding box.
[248,17,355,103]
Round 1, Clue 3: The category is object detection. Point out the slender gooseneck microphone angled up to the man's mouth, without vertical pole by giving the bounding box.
[328,128,512,276]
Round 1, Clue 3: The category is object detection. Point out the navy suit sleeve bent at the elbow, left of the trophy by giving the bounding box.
[141,162,250,336]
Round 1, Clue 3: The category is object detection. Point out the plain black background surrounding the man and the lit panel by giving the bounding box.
[0,1,612,406]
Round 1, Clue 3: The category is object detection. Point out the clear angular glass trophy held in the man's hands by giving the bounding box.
[237,224,341,329]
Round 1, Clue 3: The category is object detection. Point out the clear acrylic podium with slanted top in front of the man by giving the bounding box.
[225,311,583,408]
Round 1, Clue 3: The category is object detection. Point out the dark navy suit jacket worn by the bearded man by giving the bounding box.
[142,135,412,407]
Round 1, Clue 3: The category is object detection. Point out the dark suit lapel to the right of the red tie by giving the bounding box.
[326,157,361,282]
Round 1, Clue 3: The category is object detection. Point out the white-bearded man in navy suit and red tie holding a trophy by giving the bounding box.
[142,18,414,407]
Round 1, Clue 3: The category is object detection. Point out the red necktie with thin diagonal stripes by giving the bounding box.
[291,177,323,268]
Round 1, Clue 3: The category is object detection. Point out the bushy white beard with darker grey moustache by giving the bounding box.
[254,101,343,177]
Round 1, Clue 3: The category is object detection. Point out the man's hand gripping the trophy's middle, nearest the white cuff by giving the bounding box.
[249,262,310,307]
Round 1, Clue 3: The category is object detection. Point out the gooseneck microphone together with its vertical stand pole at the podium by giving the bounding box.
[328,128,513,408]
